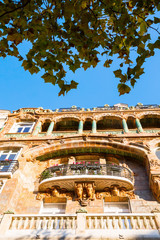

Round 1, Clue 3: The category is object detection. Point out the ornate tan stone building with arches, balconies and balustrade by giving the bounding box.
[0,104,160,239]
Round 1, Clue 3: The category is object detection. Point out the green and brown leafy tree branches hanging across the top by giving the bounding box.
[0,0,160,95]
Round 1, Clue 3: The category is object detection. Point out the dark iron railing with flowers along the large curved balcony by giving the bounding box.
[40,164,134,182]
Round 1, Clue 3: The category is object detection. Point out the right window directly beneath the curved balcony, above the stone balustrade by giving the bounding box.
[104,202,130,213]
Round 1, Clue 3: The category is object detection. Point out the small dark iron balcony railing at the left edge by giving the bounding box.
[0,160,19,174]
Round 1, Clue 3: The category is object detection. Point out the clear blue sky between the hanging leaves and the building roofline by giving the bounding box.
[0,45,160,111]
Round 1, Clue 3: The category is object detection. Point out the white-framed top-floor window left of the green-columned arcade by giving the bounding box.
[10,122,35,133]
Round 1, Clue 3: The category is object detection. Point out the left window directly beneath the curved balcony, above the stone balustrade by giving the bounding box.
[40,203,66,214]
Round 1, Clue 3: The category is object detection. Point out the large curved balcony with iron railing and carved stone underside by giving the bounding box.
[39,163,134,191]
